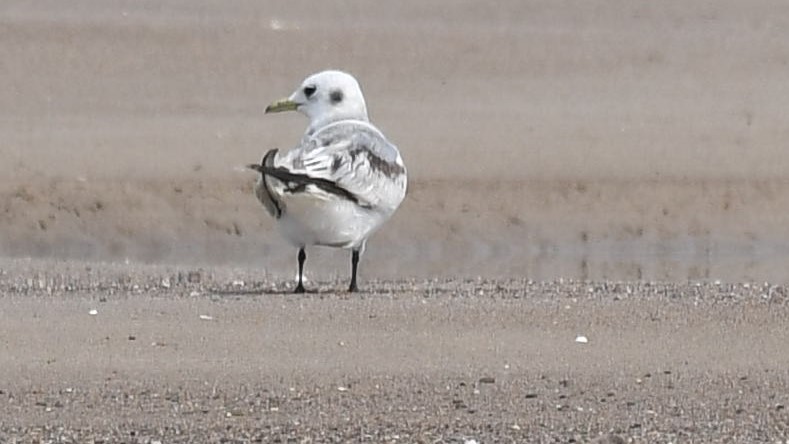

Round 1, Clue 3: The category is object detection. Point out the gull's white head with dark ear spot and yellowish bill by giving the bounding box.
[266,71,367,129]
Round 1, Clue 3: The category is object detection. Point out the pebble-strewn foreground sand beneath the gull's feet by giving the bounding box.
[0,261,789,443]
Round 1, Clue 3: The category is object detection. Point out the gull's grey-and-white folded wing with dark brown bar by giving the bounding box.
[277,121,407,209]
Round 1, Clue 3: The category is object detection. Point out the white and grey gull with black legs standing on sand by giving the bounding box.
[249,70,408,293]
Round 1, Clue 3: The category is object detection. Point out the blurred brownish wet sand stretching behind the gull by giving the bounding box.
[0,0,789,282]
